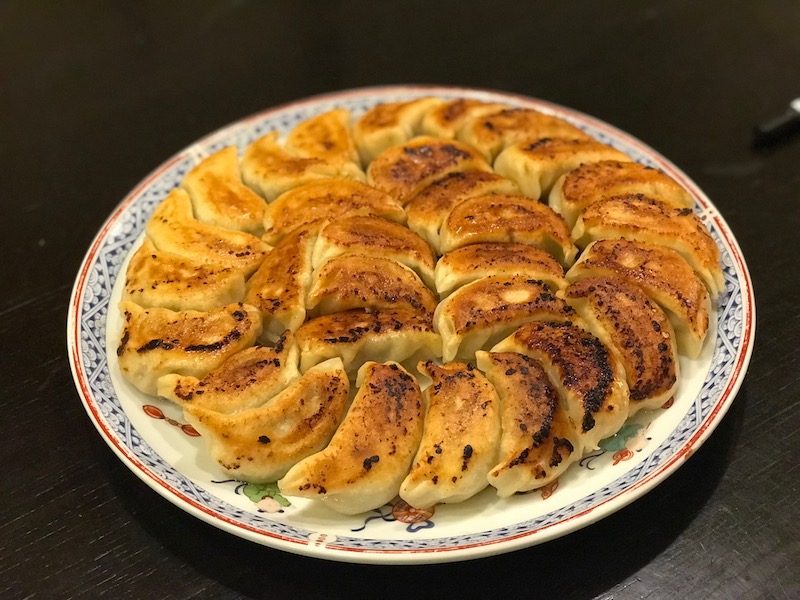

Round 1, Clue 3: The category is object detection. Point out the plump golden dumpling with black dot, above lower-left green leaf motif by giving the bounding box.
[183,359,350,483]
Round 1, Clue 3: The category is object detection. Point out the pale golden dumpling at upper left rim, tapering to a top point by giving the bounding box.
[181,146,267,236]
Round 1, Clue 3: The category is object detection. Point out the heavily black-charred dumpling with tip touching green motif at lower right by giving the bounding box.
[492,321,628,450]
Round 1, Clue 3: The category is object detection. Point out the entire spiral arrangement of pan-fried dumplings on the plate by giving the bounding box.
[117,97,724,514]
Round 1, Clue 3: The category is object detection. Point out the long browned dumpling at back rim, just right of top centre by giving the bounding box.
[458,108,588,162]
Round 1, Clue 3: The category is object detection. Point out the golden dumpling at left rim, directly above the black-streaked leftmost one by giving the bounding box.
[122,238,246,310]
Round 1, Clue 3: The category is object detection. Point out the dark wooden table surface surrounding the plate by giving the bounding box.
[0,0,800,599]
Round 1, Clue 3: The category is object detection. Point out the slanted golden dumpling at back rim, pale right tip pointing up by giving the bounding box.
[353,98,443,166]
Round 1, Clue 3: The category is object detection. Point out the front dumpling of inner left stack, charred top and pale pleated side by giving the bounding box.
[296,308,442,371]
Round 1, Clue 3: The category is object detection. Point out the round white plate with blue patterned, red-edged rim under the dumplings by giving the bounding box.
[67,86,755,564]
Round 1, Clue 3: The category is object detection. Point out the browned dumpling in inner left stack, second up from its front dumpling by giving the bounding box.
[306,254,436,316]
